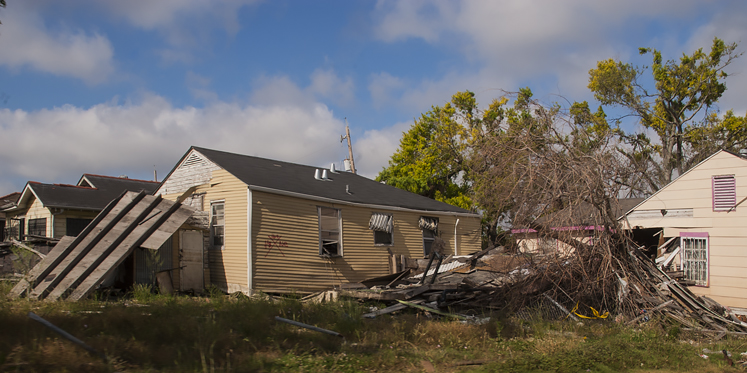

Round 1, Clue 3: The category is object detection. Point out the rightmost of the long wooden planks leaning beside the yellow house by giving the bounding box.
[67,199,194,300]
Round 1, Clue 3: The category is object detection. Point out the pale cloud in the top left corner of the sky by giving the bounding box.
[0,6,114,84]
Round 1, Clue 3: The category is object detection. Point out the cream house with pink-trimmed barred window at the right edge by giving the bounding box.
[626,150,747,307]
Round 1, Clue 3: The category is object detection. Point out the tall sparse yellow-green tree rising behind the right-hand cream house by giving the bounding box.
[589,38,743,192]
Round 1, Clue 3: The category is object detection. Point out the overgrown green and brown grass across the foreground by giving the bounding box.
[0,282,747,372]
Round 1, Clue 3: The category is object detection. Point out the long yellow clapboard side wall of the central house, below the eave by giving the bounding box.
[252,191,480,292]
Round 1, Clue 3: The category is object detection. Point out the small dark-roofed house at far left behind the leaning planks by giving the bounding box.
[2,174,159,240]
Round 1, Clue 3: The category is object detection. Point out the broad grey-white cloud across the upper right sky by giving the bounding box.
[369,0,747,109]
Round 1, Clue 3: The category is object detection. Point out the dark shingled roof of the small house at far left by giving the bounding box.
[22,174,158,210]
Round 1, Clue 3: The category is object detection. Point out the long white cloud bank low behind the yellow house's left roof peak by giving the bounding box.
[0,91,347,195]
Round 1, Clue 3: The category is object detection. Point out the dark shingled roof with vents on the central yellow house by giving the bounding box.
[191,147,471,213]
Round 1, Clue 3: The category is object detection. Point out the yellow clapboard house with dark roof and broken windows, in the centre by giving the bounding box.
[156,147,481,294]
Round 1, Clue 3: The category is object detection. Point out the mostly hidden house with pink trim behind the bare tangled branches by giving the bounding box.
[511,198,643,254]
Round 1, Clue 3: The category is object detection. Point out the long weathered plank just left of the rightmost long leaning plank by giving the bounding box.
[46,196,161,301]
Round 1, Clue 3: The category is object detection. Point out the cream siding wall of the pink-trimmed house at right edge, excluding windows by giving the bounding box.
[627,152,747,307]
